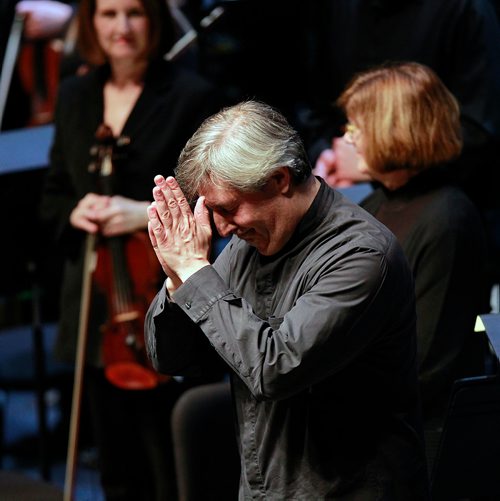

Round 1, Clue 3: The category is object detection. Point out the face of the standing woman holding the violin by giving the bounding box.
[94,0,149,62]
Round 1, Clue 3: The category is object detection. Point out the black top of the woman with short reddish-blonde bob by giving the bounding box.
[361,167,486,417]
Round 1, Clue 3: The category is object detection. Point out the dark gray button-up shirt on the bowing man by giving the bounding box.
[146,183,428,501]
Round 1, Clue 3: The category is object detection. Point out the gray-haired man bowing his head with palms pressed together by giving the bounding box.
[146,101,428,501]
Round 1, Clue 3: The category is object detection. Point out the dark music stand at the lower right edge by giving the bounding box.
[431,315,500,501]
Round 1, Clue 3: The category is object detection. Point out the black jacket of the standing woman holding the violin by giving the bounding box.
[41,61,218,364]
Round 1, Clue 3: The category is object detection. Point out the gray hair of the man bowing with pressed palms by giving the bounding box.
[175,101,311,200]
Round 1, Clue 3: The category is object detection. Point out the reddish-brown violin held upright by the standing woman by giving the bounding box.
[91,124,166,390]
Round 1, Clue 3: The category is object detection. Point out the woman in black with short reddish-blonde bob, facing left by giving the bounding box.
[339,63,486,436]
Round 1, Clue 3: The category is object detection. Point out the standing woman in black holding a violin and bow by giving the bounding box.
[41,0,219,501]
